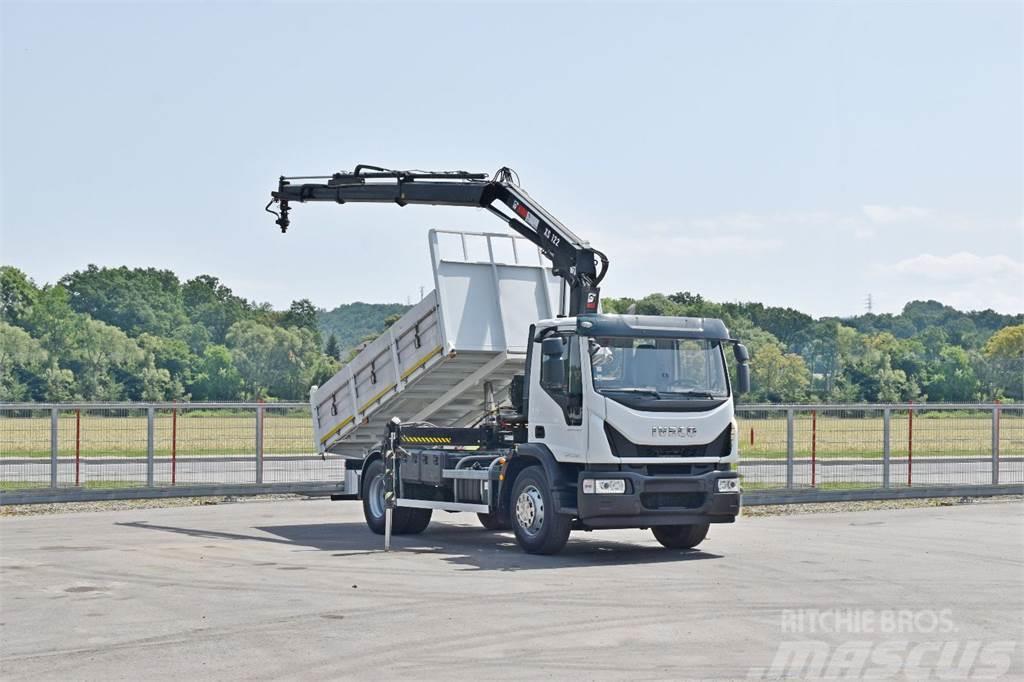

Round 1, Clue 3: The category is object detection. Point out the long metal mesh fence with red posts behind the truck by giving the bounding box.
[0,402,1024,504]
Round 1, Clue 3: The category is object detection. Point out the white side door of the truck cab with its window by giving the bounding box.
[528,334,587,462]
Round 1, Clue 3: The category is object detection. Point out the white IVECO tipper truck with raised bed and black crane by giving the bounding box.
[266,165,750,554]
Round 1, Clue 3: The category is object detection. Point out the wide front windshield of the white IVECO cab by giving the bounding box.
[589,337,729,399]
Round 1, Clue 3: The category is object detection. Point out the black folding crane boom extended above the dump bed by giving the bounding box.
[266,164,608,314]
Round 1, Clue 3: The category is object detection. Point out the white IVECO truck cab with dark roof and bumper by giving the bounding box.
[513,314,745,544]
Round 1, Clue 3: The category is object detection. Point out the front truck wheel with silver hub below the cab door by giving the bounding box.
[509,466,572,554]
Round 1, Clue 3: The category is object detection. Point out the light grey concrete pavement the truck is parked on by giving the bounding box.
[0,500,1024,680]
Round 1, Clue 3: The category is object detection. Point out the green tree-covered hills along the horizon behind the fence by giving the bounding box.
[0,265,1024,402]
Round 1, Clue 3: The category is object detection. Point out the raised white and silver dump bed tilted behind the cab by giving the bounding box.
[309,229,559,458]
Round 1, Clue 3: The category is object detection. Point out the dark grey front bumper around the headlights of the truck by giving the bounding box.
[577,471,740,528]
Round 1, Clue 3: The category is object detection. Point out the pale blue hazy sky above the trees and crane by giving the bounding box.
[0,0,1024,315]
